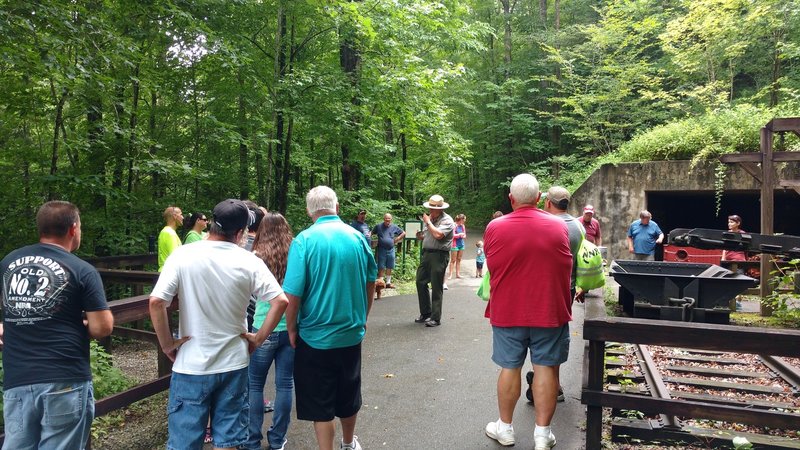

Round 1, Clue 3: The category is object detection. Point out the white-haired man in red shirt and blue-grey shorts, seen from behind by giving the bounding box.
[484,174,572,450]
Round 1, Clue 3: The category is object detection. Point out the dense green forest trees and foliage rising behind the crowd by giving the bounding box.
[0,0,800,254]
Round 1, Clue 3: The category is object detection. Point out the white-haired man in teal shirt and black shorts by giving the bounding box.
[283,186,378,450]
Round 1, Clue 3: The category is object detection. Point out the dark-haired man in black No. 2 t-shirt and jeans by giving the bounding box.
[0,201,114,449]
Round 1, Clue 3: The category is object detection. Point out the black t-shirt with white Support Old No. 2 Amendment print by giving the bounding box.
[0,244,108,389]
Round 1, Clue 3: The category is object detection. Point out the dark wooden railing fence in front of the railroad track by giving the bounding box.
[581,301,800,450]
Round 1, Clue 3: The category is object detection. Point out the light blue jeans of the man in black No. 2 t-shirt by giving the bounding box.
[3,381,94,450]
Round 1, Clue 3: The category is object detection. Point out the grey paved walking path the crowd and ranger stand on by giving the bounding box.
[272,229,602,450]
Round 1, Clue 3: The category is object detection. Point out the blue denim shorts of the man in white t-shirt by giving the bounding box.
[167,367,250,450]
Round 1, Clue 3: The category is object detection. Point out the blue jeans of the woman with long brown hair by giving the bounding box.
[244,330,294,450]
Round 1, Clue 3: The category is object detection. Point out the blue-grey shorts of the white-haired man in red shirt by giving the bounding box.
[492,324,569,369]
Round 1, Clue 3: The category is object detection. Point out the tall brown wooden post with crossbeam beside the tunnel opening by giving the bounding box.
[719,117,800,316]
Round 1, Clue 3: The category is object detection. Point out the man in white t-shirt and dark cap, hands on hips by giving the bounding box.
[150,199,288,449]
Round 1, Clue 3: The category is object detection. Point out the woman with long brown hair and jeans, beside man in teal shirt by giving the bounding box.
[241,212,294,450]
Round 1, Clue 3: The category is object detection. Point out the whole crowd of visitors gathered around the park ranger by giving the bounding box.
[0,174,720,450]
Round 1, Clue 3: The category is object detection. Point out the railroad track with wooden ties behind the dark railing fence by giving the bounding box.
[606,344,800,449]
